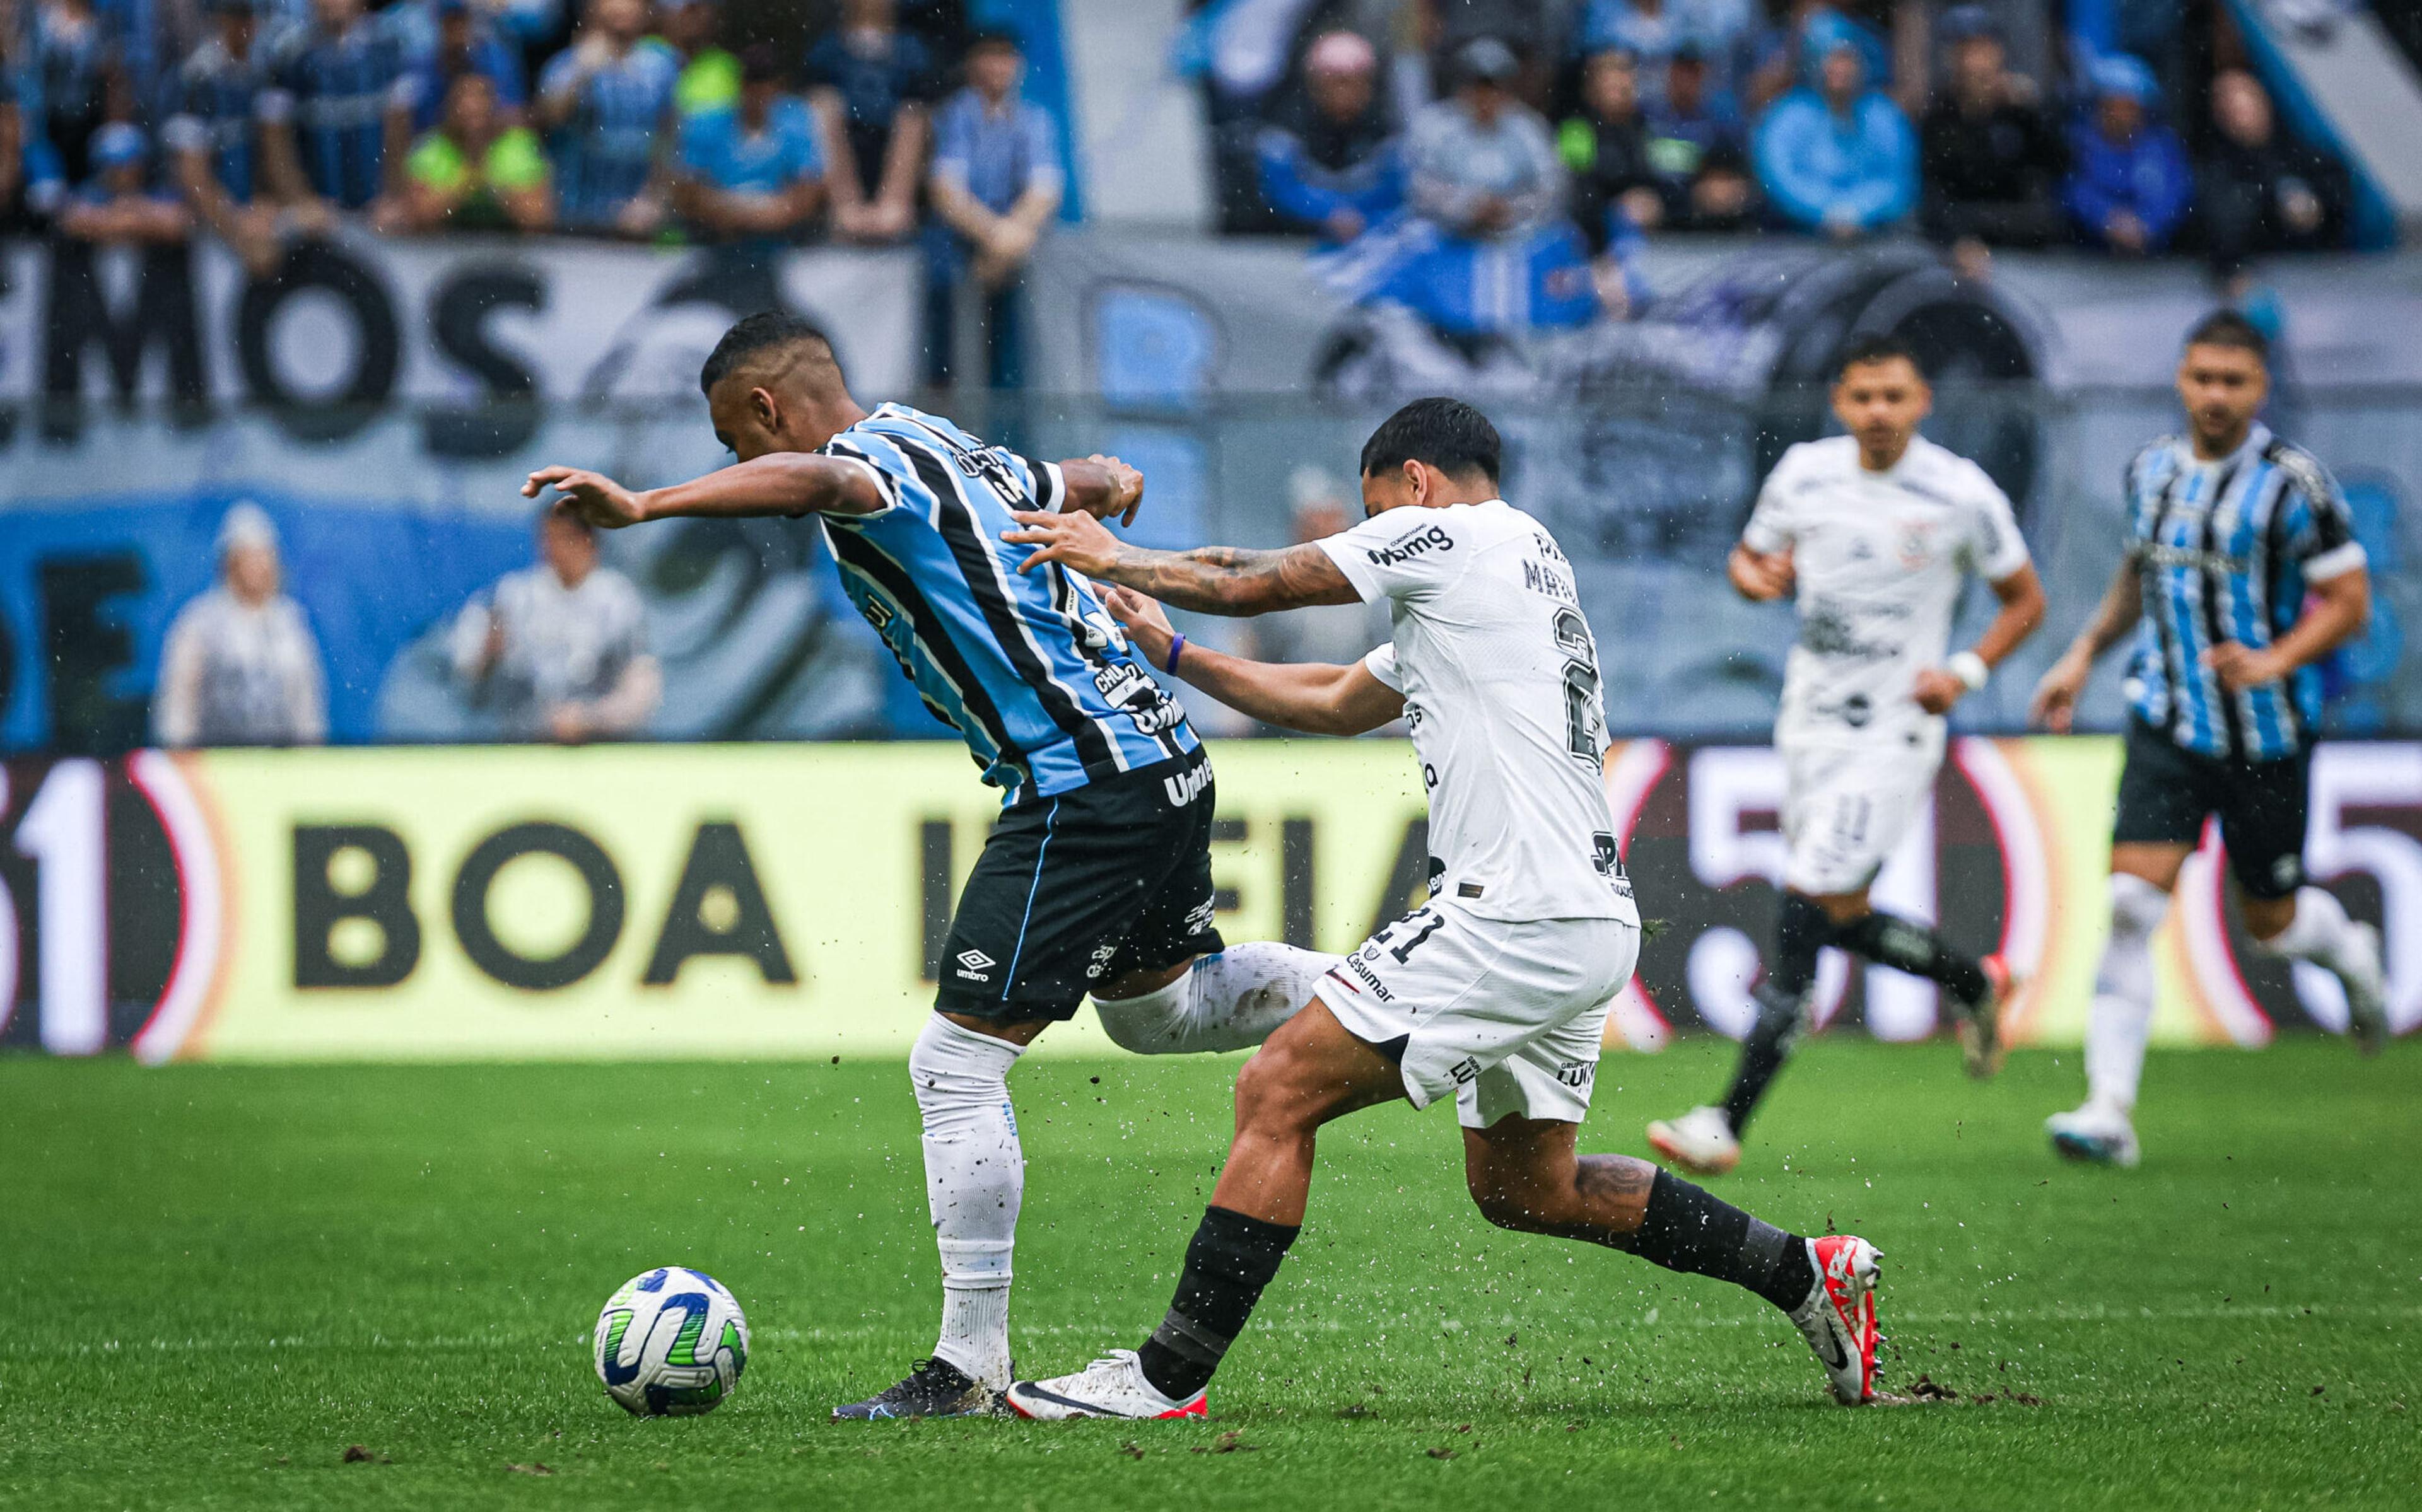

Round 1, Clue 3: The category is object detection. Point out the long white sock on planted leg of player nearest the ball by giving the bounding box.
[908,1013,1027,1386]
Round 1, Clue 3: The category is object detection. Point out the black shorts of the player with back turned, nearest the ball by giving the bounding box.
[935,751,1223,1023]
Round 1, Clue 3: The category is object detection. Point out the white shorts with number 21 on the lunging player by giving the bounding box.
[1315,904,1640,1129]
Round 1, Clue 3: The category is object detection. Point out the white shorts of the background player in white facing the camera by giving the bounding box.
[1782,741,1943,897]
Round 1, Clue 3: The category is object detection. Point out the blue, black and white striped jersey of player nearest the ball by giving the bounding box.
[821,405,1199,802]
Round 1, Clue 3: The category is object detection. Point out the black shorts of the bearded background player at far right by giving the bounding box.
[2112,719,2313,899]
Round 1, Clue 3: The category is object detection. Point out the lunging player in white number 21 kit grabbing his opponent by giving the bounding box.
[983,400,1877,1417]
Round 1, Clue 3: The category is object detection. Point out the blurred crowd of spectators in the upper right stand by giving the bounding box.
[1220,0,2352,301]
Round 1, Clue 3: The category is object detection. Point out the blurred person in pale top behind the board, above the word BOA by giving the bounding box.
[453,509,664,744]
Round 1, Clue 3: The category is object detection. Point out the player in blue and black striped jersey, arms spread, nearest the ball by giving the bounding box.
[523,313,1337,1417]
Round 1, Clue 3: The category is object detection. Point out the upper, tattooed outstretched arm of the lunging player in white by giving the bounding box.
[1000,509,1361,615]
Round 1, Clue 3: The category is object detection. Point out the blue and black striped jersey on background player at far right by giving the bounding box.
[2124,422,2364,761]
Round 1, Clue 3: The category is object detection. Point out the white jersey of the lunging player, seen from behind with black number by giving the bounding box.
[1320,499,1640,923]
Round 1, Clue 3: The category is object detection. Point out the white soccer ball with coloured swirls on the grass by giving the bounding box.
[596,1265,749,1417]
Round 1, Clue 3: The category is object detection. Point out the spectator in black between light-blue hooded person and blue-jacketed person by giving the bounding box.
[1918,8,2068,276]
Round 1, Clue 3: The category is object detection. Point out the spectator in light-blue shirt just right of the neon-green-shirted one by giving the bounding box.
[537,0,681,238]
